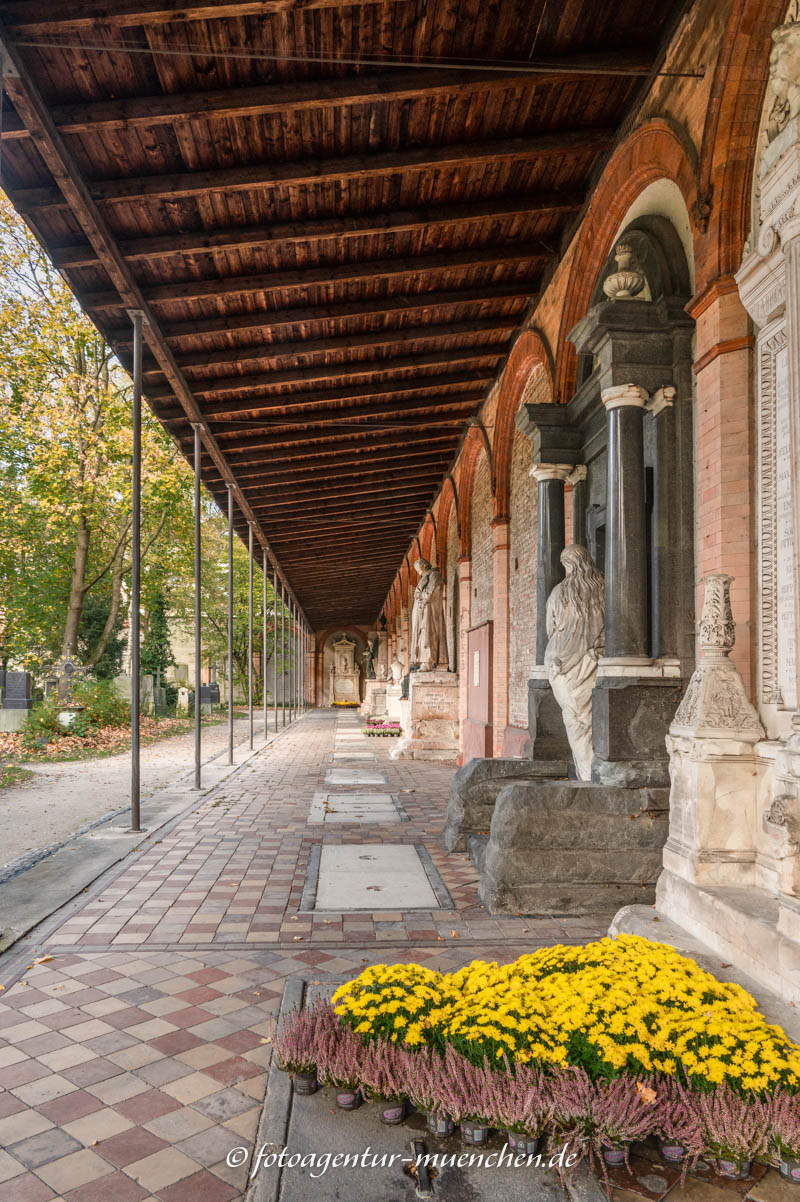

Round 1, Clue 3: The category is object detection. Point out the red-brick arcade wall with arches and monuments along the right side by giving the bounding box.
[376,0,800,996]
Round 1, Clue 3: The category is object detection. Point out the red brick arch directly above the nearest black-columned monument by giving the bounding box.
[554,118,698,404]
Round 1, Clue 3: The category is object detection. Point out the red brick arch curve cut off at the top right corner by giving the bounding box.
[689,0,788,284]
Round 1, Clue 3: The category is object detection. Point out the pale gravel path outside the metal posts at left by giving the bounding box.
[0,718,253,868]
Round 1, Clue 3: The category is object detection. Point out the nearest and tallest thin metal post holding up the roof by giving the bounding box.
[127,310,143,831]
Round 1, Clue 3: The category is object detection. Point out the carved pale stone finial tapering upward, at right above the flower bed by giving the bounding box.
[669,572,764,743]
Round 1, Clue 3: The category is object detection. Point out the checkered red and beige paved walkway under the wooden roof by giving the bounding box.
[0,712,771,1202]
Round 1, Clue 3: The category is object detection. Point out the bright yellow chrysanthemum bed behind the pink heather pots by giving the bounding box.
[333,935,800,1094]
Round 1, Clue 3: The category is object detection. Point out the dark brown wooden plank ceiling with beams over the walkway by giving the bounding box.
[0,0,681,629]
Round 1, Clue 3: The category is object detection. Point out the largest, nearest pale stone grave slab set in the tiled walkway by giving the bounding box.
[315,843,440,911]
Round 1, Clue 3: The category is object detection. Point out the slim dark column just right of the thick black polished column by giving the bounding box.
[645,385,677,659]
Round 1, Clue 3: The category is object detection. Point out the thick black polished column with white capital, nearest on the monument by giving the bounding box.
[601,383,651,666]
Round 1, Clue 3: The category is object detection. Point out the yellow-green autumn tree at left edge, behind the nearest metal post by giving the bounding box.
[0,195,191,672]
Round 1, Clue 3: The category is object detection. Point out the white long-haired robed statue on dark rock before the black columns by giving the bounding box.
[544,545,605,780]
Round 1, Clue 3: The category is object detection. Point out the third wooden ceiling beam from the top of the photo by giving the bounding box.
[14,127,614,213]
